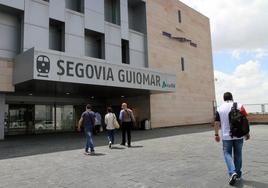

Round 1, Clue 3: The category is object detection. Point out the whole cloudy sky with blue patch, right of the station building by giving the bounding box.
[181,0,268,110]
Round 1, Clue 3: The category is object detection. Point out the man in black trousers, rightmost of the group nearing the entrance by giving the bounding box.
[119,103,135,147]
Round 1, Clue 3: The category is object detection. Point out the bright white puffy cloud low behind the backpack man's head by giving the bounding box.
[214,60,268,105]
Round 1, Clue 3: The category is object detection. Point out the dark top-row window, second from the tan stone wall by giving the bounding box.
[105,0,120,25]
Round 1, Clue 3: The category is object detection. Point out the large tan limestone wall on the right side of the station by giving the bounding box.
[146,0,215,127]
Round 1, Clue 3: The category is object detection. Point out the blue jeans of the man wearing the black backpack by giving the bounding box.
[222,139,244,177]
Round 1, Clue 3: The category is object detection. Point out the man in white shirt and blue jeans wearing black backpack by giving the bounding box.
[214,92,250,185]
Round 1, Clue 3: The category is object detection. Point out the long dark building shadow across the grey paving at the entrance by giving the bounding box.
[0,125,212,160]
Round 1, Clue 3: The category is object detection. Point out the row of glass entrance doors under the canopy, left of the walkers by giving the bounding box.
[5,104,75,135]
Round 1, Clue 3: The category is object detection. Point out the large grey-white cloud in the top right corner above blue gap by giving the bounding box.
[181,0,268,51]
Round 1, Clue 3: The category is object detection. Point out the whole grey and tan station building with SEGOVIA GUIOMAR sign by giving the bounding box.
[0,0,215,139]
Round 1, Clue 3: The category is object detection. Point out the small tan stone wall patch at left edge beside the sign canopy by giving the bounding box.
[0,60,15,92]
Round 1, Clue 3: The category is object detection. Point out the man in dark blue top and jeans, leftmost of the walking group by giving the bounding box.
[78,104,95,155]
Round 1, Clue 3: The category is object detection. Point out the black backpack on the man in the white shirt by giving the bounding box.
[229,102,249,138]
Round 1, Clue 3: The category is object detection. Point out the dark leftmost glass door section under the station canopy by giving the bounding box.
[7,104,34,135]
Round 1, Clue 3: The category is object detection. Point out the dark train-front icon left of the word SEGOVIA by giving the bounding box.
[36,55,50,78]
